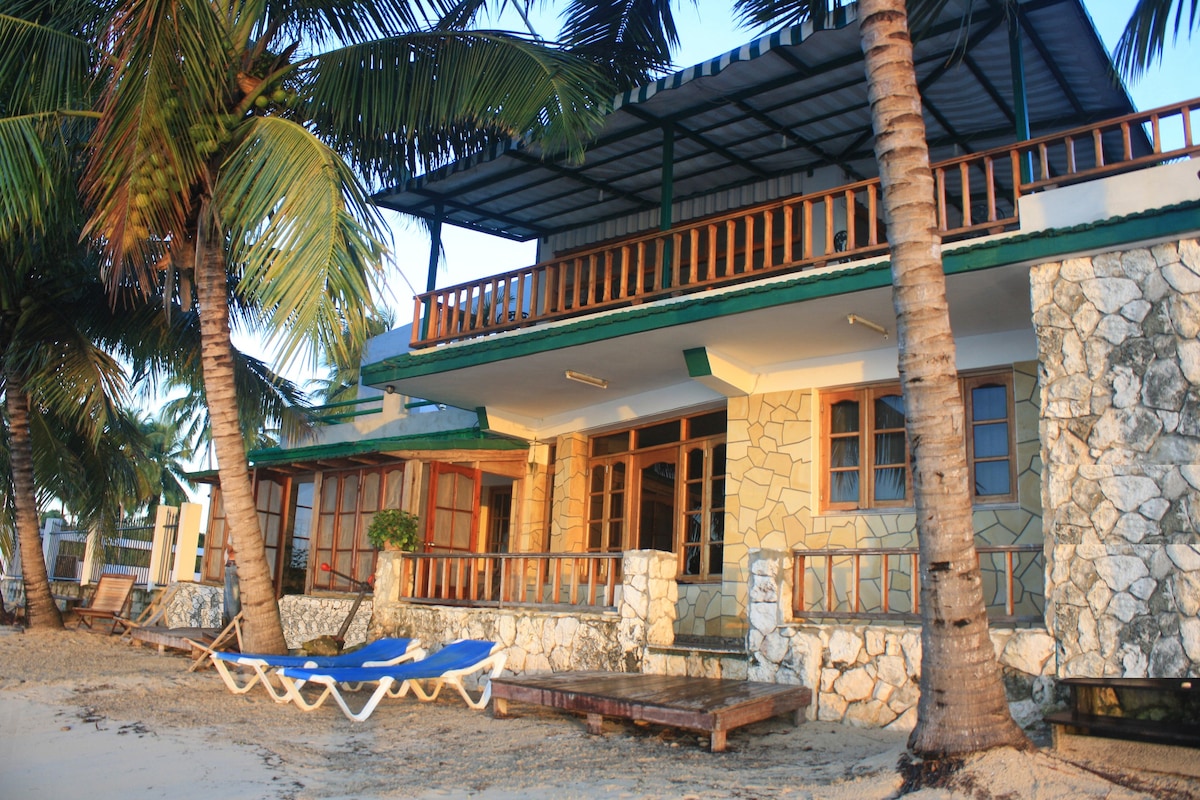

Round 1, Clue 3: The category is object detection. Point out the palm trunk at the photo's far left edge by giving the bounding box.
[5,375,62,628]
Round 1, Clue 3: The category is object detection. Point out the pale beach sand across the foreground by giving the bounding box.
[0,628,1200,800]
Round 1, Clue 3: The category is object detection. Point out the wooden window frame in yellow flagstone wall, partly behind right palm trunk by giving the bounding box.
[817,369,1018,513]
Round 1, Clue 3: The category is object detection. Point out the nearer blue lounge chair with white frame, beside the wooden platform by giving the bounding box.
[277,639,506,722]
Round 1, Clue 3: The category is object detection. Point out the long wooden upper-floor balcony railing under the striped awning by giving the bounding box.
[412,100,1200,348]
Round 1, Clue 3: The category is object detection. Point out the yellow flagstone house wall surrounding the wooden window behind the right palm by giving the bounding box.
[722,362,1044,619]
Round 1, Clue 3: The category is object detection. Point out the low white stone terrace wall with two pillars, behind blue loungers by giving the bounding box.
[371,551,678,675]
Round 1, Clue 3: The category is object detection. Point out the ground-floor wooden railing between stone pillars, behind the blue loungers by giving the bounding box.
[400,553,622,610]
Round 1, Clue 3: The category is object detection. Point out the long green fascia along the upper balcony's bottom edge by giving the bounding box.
[362,201,1200,384]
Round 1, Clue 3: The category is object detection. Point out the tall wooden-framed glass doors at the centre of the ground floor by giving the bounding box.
[584,410,726,581]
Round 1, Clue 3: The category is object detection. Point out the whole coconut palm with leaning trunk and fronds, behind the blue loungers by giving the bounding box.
[72,0,604,652]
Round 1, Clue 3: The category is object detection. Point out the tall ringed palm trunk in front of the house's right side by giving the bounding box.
[859,0,1028,757]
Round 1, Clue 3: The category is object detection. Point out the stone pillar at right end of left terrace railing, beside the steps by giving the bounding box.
[617,551,679,672]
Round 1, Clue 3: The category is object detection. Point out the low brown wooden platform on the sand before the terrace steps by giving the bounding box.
[492,672,812,753]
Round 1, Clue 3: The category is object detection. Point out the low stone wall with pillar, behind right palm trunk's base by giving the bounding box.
[748,551,1056,730]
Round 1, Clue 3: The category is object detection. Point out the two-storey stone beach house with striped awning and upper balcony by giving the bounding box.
[192,0,1200,726]
